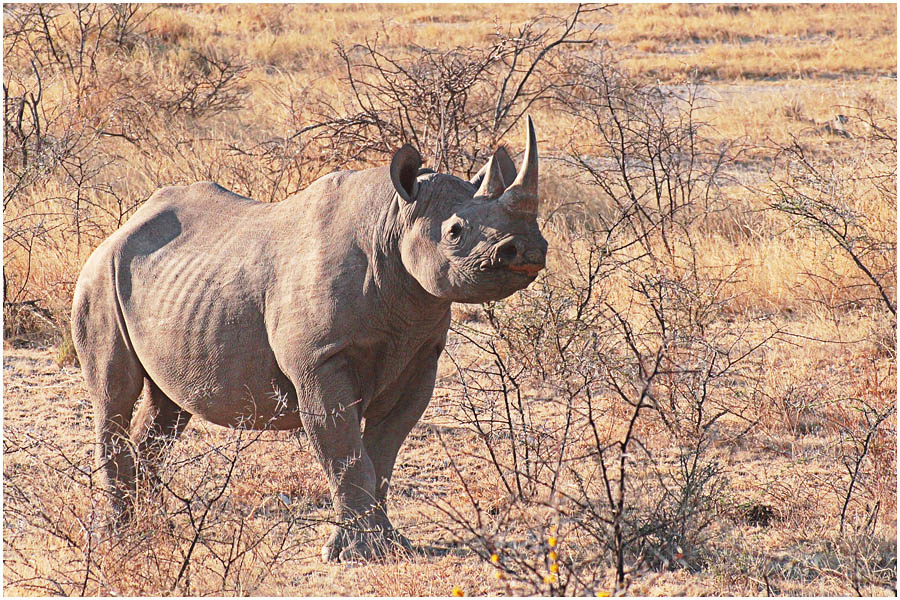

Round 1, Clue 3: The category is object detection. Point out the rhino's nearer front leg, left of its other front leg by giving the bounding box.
[295,357,390,560]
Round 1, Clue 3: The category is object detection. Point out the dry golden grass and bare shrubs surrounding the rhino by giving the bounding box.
[3,4,897,595]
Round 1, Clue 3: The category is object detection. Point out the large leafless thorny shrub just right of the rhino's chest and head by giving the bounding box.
[428,61,777,595]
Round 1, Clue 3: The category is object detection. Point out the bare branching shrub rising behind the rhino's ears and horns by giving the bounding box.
[308,5,602,175]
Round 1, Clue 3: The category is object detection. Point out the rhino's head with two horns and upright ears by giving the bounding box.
[390,117,547,302]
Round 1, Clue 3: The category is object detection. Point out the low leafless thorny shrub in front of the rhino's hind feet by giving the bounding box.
[3,428,328,595]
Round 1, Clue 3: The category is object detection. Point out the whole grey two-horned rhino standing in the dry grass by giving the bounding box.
[72,119,547,560]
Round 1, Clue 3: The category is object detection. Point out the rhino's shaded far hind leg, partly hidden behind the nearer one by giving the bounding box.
[131,378,191,490]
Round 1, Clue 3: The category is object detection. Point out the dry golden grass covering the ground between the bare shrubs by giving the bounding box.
[3,4,897,596]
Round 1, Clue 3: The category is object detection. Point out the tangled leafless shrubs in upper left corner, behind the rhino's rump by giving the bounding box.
[3,4,251,340]
